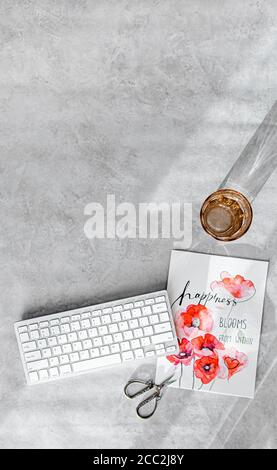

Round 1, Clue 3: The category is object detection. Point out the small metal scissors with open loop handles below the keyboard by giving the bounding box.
[124,375,176,419]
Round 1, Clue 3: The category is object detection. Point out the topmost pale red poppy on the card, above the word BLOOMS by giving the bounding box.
[211,271,253,300]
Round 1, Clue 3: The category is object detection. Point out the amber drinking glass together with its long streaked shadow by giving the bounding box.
[200,101,277,241]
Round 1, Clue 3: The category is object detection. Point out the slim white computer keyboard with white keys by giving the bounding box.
[15,291,178,384]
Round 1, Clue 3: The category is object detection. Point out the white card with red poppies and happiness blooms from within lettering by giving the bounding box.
[156,250,268,398]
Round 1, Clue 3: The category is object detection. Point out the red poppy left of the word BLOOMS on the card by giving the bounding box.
[176,304,214,338]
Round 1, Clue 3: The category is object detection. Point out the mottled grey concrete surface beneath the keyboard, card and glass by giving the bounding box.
[0,0,277,448]
